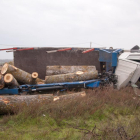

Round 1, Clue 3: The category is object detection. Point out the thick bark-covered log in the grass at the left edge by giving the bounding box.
[0,94,53,114]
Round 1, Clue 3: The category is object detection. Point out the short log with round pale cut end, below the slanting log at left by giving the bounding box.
[4,73,19,87]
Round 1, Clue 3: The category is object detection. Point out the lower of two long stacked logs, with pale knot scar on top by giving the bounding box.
[45,70,98,84]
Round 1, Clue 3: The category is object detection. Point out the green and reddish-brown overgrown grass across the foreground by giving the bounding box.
[0,87,140,140]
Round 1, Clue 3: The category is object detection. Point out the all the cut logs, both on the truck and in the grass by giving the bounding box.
[0,63,98,114]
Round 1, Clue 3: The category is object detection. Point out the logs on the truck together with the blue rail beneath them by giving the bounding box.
[0,63,100,95]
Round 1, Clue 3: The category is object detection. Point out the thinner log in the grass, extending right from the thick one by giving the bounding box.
[53,91,86,101]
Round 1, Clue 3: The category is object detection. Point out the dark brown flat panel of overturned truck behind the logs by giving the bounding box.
[14,48,100,79]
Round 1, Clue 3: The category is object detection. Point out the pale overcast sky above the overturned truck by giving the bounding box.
[0,0,140,59]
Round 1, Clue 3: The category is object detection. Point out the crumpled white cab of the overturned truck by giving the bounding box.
[115,52,140,89]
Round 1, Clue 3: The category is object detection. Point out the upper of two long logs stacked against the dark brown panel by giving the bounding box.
[46,65,96,76]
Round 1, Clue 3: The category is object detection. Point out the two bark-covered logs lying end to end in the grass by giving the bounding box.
[0,91,86,114]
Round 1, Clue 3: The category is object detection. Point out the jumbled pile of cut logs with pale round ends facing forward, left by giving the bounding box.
[0,63,44,89]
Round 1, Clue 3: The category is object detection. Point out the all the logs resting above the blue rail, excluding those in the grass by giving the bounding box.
[0,63,98,89]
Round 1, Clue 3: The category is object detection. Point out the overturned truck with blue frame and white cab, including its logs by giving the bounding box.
[0,48,139,94]
